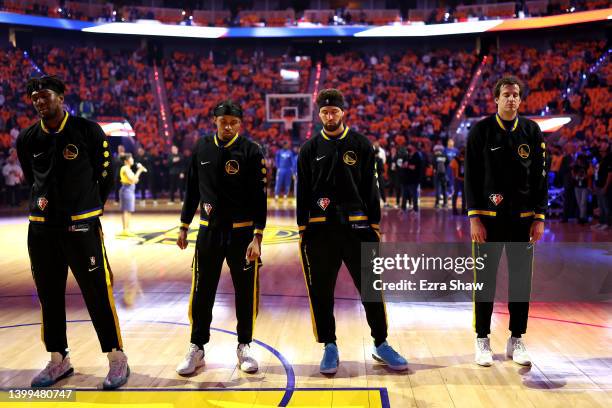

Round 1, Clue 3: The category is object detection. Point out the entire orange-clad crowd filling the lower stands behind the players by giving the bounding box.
[0,37,612,229]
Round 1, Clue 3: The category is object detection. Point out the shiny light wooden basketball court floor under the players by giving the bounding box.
[0,205,612,408]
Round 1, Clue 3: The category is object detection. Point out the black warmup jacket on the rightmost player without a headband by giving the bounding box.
[465,114,548,220]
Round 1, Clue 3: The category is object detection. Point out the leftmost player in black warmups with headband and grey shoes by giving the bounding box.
[17,76,130,389]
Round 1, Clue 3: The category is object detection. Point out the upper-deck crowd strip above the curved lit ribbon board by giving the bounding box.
[0,0,610,27]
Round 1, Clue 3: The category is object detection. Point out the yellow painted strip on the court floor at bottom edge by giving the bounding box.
[0,388,388,408]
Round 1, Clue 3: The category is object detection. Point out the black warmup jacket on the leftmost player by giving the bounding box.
[17,112,113,225]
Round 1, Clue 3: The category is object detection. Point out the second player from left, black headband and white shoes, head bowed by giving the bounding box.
[176,100,267,375]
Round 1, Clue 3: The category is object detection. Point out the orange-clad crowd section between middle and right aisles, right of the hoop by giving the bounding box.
[323,49,477,148]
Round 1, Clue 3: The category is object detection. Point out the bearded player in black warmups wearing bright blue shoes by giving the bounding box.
[297,89,408,374]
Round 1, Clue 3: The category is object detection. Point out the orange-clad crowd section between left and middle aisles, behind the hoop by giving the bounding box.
[163,50,311,153]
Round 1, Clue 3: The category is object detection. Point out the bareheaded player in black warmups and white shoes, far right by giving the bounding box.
[465,77,548,366]
